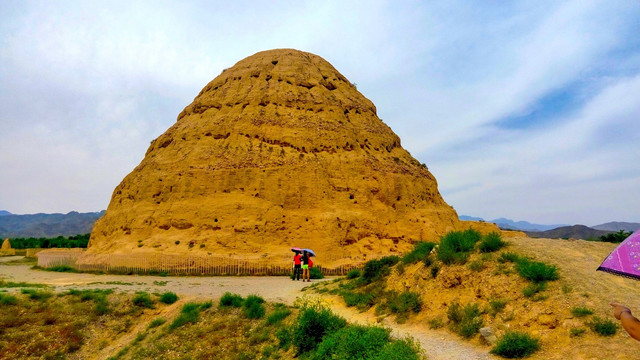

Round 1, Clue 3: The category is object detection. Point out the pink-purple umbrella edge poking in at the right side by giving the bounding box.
[598,229,640,279]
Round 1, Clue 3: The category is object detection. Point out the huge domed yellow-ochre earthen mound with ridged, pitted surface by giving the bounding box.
[89,49,459,256]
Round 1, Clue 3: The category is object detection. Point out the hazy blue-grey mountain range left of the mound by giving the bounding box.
[0,210,104,239]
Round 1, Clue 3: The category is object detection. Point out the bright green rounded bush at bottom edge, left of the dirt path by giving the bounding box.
[313,325,390,360]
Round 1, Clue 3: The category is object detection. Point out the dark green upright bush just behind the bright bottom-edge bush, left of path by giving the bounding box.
[291,307,347,355]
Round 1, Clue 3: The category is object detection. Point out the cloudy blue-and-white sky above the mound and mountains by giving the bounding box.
[0,0,640,225]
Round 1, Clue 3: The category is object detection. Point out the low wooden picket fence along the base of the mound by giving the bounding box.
[37,250,373,276]
